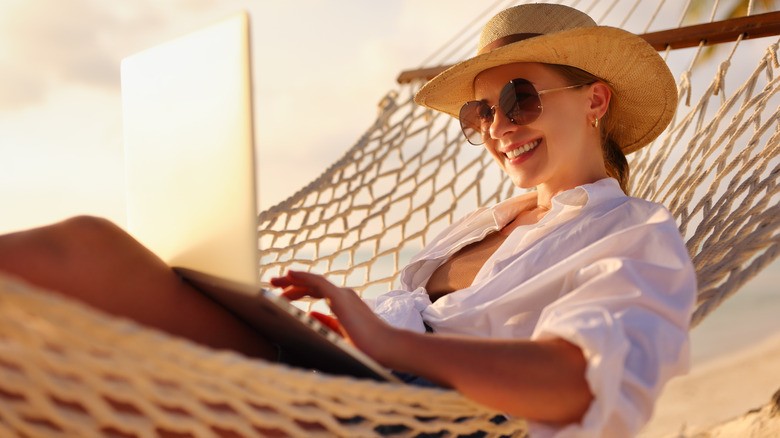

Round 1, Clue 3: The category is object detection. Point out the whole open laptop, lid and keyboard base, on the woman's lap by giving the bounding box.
[121,12,398,381]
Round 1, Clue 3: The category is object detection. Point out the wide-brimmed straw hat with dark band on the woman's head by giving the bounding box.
[415,4,677,154]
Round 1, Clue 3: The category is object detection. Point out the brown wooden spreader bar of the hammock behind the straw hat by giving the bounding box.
[396,11,780,84]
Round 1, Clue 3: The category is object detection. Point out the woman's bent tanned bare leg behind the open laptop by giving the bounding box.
[0,216,276,360]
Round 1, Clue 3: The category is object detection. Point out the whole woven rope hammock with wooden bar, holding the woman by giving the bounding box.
[0,0,780,437]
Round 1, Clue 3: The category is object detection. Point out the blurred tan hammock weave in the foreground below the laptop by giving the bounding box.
[0,277,522,437]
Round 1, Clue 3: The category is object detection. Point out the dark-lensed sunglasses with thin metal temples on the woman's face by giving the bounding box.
[458,78,585,146]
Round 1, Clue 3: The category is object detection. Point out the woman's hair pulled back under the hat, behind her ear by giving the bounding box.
[545,64,630,195]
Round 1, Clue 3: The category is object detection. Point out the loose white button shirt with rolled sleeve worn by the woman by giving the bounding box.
[374,178,696,438]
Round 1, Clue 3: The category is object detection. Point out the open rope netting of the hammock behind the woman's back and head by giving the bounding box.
[258,1,780,324]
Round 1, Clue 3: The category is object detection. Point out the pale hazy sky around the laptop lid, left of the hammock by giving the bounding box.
[0,0,485,232]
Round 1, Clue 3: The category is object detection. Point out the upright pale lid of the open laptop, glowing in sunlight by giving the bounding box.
[122,13,258,285]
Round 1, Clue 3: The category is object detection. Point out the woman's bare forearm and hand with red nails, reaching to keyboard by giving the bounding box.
[272,272,592,423]
